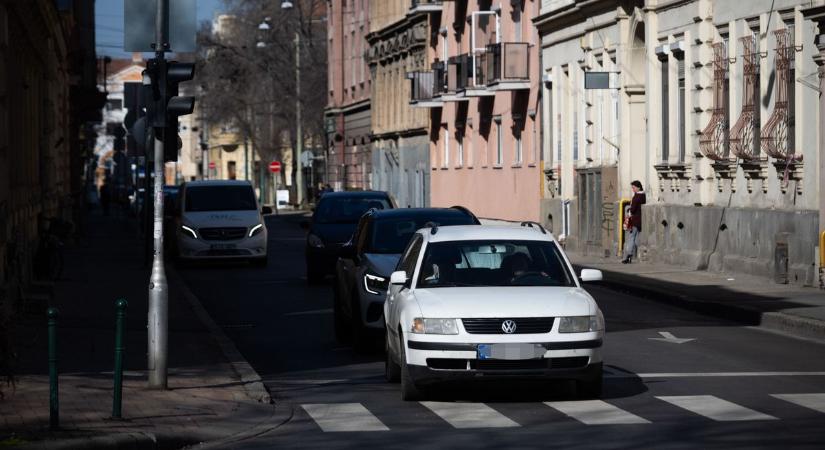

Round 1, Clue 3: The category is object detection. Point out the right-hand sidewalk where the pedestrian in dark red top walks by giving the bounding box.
[568,252,825,339]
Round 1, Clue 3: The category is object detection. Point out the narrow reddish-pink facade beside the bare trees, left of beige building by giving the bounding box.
[324,0,372,190]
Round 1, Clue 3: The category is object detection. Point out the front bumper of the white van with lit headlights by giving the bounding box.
[177,232,267,261]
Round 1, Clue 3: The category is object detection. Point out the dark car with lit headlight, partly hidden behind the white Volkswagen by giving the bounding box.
[333,206,480,346]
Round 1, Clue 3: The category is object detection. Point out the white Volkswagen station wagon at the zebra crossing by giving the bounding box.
[384,222,604,400]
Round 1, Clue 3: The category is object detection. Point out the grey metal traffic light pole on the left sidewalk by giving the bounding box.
[148,0,169,389]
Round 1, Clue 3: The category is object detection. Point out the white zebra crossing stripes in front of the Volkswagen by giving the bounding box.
[301,393,825,432]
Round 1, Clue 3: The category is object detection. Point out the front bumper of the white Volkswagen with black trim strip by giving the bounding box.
[406,333,603,384]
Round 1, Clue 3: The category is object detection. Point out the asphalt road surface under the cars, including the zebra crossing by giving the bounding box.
[180,215,825,449]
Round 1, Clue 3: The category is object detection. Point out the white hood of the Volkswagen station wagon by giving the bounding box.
[415,286,597,318]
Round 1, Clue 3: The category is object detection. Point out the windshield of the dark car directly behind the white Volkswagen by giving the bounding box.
[365,214,475,253]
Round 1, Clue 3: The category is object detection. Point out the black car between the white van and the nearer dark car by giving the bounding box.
[303,191,395,284]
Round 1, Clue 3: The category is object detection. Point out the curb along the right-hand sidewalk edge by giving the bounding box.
[573,263,825,340]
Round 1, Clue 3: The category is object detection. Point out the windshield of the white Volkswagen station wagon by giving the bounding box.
[418,240,575,288]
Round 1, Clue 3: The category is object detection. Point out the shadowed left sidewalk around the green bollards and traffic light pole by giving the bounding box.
[0,214,283,449]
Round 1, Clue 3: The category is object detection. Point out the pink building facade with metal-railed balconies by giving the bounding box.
[408,0,543,221]
